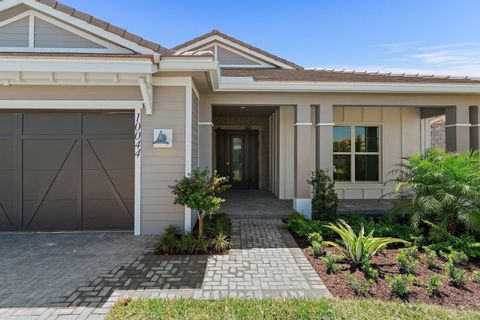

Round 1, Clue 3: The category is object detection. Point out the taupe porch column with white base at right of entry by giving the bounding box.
[293,103,312,218]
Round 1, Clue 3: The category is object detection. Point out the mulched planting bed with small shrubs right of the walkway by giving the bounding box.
[286,214,480,310]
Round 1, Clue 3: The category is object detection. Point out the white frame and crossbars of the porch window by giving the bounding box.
[332,123,383,184]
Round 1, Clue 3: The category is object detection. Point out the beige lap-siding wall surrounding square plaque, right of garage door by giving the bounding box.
[141,86,186,234]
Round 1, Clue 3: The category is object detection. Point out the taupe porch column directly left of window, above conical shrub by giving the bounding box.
[315,103,333,177]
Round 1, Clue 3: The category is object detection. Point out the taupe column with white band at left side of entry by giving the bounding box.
[198,100,213,171]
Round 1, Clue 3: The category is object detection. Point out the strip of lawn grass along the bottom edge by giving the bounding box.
[107,299,480,320]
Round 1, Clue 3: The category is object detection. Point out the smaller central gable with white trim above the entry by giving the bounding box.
[173,30,303,69]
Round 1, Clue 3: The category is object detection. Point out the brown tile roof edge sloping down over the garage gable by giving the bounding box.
[35,0,175,55]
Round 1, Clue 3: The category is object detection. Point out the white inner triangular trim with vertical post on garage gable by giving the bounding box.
[0,10,132,54]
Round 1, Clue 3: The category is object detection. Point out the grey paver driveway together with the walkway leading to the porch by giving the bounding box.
[0,219,330,320]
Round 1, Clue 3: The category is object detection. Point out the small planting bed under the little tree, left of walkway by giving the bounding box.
[155,213,231,255]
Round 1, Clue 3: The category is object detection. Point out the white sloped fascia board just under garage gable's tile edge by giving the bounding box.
[0,0,157,54]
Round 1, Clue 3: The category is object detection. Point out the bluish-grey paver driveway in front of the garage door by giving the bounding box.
[0,232,155,319]
